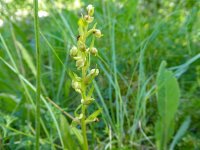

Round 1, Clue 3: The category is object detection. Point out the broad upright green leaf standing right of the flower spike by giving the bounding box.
[155,62,180,150]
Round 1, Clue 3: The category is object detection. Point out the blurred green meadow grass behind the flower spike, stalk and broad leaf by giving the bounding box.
[0,0,200,150]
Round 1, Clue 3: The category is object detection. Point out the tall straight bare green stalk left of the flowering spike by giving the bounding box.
[34,0,41,150]
